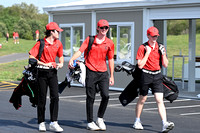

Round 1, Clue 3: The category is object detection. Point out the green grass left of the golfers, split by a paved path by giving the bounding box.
[0,38,36,81]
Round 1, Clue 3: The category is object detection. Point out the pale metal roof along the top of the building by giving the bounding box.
[43,0,200,12]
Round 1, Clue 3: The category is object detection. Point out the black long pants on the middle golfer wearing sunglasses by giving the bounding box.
[86,68,109,123]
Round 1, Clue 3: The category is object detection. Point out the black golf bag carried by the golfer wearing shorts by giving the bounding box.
[115,61,179,106]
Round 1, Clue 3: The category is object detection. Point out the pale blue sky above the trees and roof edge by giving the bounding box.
[0,0,78,13]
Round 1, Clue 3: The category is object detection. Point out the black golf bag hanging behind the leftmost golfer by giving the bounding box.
[9,59,38,110]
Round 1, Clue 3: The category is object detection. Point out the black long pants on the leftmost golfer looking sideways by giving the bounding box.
[37,69,59,123]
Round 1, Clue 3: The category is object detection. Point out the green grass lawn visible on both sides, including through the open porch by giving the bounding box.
[0,34,200,81]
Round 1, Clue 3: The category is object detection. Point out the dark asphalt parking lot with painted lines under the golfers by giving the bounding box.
[0,82,200,133]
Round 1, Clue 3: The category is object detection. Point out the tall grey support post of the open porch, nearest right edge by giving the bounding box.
[188,19,196,92]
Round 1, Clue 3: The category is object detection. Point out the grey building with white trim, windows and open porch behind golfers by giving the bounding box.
[43,0,200,92]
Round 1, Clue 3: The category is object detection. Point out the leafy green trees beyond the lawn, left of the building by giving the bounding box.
[0,3,48,40]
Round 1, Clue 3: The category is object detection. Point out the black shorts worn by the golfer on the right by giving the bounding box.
[140,72,163,96]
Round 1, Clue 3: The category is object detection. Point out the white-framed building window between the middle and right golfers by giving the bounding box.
[107,22,134,63]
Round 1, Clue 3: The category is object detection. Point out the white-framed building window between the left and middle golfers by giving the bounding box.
[60,24,85,59]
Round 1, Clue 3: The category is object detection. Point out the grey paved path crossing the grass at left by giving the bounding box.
[0,53,29,64]
